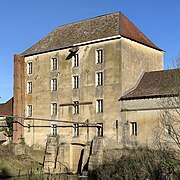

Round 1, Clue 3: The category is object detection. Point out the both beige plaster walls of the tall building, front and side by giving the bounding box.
[20,38,163,171]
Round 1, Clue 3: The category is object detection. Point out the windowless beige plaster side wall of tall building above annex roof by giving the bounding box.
[121,38,164,94]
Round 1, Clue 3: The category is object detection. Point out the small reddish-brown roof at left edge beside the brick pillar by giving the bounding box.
[0,98,13,116]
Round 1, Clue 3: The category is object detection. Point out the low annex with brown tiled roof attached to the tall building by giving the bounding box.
[120,68,180,149]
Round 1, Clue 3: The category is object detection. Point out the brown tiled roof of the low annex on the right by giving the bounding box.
[120,69,180,100]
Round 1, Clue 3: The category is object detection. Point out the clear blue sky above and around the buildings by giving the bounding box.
[0,0,180,103]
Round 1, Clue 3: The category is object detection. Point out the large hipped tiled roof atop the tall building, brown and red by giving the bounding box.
[22,12,160,55]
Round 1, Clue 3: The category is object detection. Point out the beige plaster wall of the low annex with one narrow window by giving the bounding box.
[121,97,179,148]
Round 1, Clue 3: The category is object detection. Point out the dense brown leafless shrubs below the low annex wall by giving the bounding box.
[91,148,180,180]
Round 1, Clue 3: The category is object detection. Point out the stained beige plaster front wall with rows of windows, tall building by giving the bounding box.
[24,40,121,171]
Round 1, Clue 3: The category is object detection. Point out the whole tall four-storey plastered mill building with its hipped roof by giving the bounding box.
[13,12,163,172]
